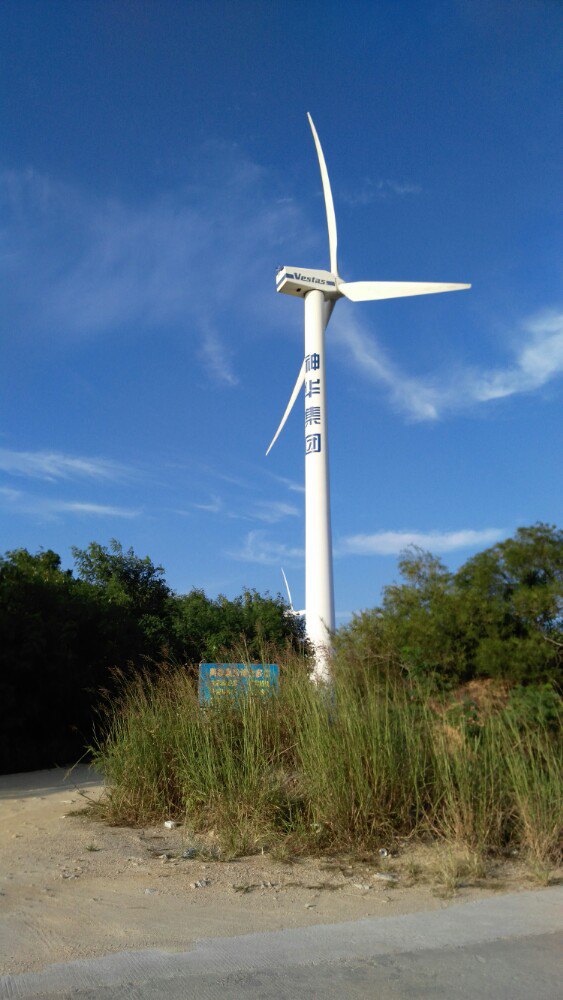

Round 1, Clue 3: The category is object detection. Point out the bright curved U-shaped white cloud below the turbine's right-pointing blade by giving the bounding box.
[333,302,563,421]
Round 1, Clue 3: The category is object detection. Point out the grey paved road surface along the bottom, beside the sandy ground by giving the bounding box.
[0,887,563,1000]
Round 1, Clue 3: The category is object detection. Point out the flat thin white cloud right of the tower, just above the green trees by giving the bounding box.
[336,528,506,556]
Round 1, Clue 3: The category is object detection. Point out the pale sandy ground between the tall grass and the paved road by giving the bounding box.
[0,767,548,973]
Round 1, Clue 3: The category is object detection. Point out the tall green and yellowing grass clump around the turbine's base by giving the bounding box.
[90,661,562,864]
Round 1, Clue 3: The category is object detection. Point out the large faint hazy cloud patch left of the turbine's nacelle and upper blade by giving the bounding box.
[0,155,309,386]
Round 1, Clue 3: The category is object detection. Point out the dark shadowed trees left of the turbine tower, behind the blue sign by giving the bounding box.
[0,540,302,772]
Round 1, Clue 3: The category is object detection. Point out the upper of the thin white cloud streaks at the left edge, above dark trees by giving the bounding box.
[0,448,130,482]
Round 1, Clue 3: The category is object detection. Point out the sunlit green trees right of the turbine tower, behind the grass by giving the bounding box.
[337,524,563,685]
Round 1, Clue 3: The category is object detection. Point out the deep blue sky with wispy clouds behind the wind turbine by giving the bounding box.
[0,0,563,621]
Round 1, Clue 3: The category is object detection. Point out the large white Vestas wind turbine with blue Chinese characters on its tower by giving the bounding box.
[266,114,471,680]
